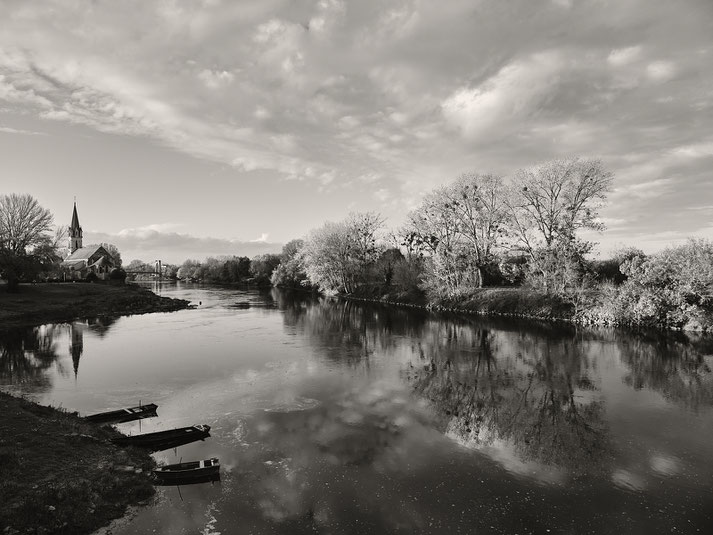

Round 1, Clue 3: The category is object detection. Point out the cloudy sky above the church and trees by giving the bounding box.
[0,0,713,262]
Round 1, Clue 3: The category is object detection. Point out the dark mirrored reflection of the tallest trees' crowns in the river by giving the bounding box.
[406,325,610,471]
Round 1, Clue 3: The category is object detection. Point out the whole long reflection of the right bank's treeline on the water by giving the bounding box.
[276,293,713,473]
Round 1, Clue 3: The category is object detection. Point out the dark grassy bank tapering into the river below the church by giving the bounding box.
[0,283,189,328]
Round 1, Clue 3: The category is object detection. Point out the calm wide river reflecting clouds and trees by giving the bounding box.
[0,283,713,535]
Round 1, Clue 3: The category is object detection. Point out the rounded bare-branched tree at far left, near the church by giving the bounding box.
[0,193,52,255]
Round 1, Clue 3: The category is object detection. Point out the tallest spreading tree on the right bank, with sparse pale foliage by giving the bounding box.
[507,158,613,293]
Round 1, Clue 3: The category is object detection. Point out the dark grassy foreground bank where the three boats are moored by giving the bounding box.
[0,392,154,535]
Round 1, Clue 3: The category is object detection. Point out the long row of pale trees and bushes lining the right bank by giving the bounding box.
[264,158,713,330]
